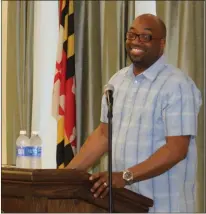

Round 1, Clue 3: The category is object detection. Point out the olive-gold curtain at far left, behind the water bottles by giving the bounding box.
[6,1,34,164]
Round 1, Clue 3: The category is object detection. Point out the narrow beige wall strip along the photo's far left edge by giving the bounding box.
[1,1,8,164]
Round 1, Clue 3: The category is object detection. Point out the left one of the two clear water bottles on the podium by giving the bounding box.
[16,130,30,169]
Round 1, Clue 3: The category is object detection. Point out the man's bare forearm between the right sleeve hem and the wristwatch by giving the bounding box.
[129,136,190,181]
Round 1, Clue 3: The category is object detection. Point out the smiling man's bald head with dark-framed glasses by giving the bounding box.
[126,14,166,69]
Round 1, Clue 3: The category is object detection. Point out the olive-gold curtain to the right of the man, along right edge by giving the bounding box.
[156,1,206,212]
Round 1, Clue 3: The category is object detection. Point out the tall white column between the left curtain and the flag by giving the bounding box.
[32,1,59,168]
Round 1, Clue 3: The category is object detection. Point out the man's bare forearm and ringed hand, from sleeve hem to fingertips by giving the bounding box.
[90,136,190,198]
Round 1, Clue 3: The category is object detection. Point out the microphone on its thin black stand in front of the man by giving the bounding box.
[104,84,114,213]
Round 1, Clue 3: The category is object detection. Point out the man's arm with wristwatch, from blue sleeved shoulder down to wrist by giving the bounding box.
[130,76,201,181]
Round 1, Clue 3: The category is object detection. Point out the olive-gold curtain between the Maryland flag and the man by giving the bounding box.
[74,1,135,170]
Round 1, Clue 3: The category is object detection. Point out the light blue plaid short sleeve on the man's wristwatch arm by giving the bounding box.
[163,81,202,136]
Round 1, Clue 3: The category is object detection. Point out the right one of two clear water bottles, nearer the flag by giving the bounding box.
[30,131,42,169]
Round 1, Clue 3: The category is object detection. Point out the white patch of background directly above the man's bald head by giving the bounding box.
[135,1,156,17]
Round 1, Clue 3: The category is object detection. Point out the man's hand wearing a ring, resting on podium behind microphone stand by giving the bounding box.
[89,172,126,198]
